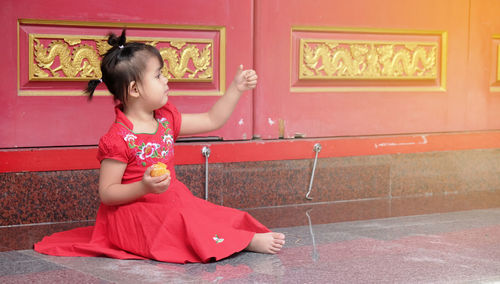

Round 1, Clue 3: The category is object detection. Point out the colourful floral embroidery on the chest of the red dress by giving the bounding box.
[123,118,174,167]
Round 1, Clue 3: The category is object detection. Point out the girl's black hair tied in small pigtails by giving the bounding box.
[85,30,163,105]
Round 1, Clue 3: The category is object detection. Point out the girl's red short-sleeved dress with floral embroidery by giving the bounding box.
[34,103,269,263]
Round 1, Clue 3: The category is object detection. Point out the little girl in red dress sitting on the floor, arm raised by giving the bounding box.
[35,30,285,263]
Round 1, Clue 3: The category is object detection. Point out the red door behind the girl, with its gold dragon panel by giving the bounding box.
[0,0,253,148]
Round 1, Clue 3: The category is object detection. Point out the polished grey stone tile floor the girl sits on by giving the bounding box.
[0,208,500,283]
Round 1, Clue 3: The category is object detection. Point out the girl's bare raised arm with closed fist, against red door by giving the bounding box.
[180,65,257,135]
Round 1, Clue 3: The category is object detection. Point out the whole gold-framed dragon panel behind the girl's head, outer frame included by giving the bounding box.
[17,19,226,96]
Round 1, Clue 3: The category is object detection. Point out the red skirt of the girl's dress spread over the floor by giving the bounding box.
[35,180,269,263]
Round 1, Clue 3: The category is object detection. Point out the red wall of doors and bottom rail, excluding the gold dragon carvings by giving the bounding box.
[0,0,500,171]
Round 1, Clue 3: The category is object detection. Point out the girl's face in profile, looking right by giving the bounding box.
[137,56,168,110]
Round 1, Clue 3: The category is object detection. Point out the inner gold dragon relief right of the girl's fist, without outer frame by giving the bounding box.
[299,39,439,80]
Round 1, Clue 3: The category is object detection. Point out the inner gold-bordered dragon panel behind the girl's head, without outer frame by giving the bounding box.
[29,34,214,82]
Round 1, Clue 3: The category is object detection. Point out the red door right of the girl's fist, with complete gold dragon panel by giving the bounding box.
[254,0,472,139]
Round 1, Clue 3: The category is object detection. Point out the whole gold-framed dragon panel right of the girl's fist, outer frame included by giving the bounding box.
[290,26,448,93]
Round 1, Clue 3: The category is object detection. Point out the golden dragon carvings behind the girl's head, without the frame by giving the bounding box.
[30,38,213,80]
